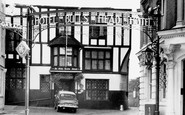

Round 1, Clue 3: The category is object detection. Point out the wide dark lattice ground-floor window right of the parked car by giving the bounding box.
[86,79,109,101]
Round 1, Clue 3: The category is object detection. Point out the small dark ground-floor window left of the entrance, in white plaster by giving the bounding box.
[40,75,50,92]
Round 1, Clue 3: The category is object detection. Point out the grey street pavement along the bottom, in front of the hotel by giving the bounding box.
[0,105,139,115]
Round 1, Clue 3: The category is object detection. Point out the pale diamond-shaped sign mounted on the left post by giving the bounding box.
[16,41,30,58]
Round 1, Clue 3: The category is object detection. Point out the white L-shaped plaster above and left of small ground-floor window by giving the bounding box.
[30,66,50,89]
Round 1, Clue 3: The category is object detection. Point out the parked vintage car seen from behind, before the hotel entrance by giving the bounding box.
[54,90,78,113]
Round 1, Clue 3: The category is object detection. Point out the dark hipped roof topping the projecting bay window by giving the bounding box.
[49,36,82,47]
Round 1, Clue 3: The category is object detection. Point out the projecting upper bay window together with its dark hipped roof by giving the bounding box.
[49,36,82,68]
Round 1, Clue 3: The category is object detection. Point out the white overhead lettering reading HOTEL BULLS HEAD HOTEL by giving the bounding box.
[33,12,153,26]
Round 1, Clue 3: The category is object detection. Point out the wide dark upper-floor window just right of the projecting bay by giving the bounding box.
[84,49,112,71]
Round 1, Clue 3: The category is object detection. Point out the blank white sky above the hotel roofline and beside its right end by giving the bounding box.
[5,0,140,80]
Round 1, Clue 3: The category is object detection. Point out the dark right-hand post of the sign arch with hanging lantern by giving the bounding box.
[142,1,160,115]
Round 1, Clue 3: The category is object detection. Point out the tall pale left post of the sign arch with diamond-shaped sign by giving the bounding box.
[9,5,35,115]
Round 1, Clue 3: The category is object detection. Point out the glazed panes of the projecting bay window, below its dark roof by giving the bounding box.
[53,47,78,67]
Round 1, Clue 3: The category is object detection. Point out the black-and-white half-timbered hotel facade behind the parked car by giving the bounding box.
[6,5,131,109]
